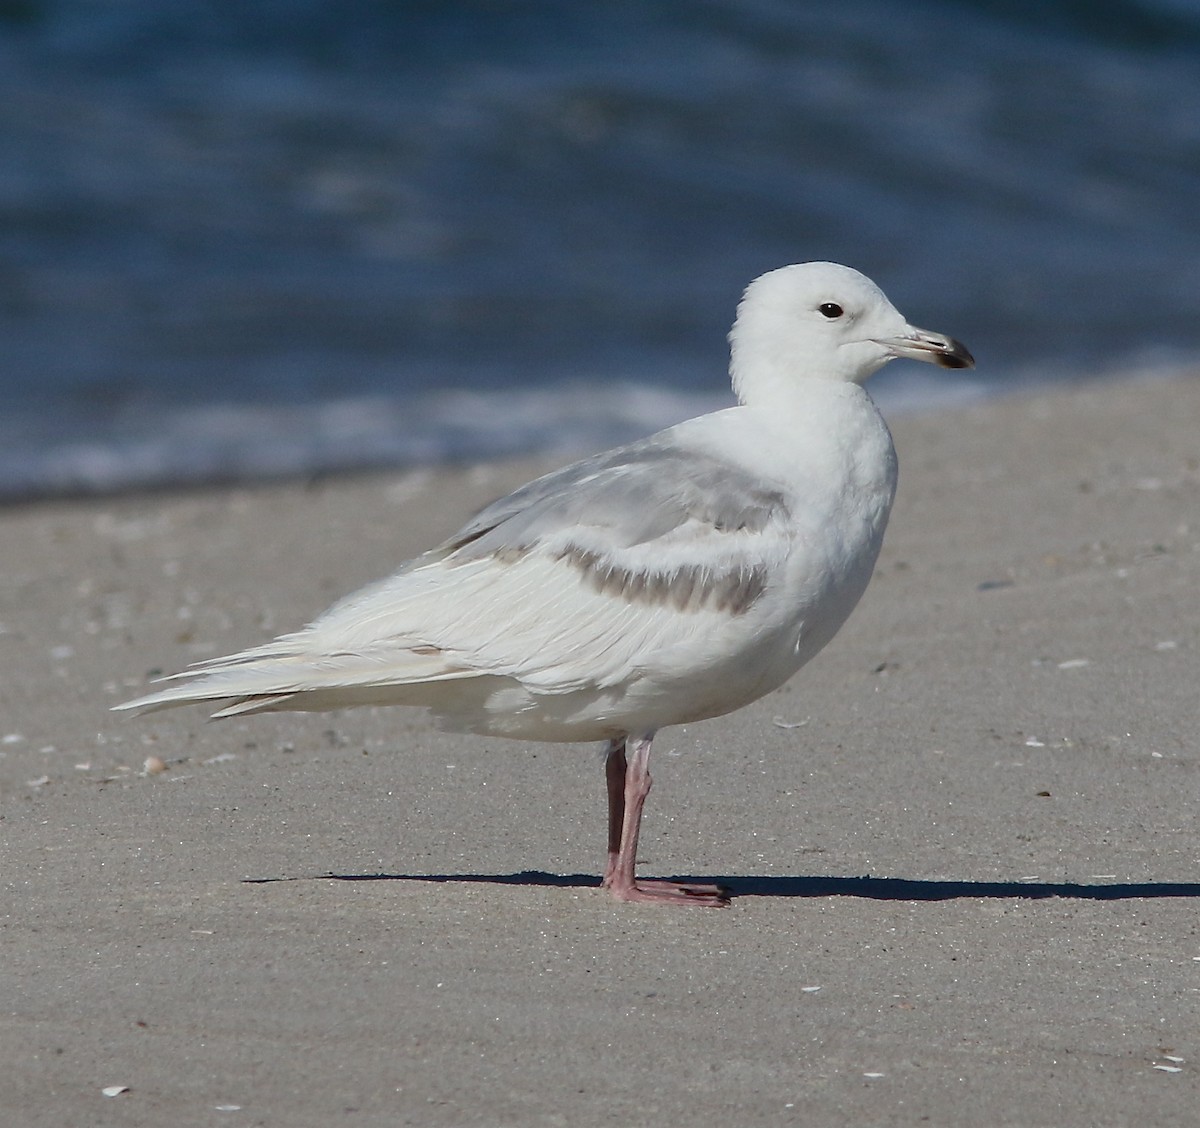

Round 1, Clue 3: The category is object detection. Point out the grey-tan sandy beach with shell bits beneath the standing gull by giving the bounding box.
[0,378,1200,1128]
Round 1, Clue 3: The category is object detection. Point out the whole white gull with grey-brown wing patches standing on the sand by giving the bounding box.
[115,263,974,906]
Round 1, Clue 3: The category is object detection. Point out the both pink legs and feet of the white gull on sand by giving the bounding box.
[604,733,730,906]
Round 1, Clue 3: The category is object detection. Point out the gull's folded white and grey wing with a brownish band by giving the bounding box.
[119,432,790,712]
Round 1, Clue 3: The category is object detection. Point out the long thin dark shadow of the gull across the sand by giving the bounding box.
[242,870,1200,901]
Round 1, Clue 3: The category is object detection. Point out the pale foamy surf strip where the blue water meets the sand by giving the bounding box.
[0,362,1200,509]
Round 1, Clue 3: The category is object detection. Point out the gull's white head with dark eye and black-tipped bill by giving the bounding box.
[730,263,974,402]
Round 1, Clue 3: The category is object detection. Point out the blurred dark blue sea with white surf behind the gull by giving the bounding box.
[0,0,1200,498]
